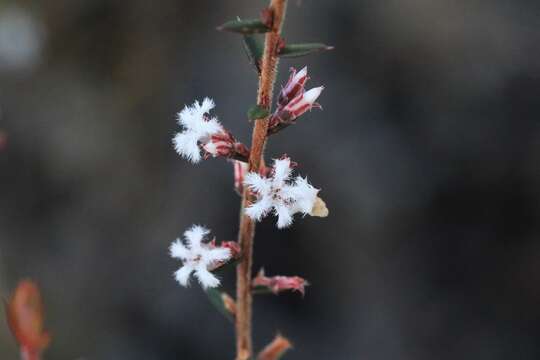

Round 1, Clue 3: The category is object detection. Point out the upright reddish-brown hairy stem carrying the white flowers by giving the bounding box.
[236,0,287,360]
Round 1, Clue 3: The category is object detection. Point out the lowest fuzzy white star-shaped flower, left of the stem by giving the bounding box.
[169,225,231,289]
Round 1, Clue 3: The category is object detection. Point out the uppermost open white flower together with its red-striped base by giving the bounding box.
[173,98,249,163]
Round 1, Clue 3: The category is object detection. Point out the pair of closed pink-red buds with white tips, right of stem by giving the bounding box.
[268,67,324,134]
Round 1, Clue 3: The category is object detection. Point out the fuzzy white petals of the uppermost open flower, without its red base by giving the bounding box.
[173,98,223,163]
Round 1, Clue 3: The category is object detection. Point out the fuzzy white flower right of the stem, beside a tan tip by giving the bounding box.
[244,158,319,229]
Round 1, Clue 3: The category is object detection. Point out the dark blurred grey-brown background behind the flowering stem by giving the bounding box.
[0,0,540,360]
